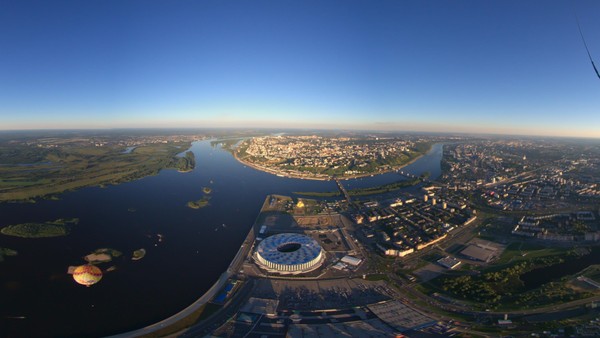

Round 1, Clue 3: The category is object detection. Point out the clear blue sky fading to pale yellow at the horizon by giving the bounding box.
[0,0,600,137]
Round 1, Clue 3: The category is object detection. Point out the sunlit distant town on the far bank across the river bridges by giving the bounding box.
[236,135,442,179]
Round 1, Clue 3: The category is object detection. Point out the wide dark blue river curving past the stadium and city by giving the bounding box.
[0,141,442,337]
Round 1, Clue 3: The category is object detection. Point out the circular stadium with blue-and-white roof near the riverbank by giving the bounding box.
[255,233,324,274]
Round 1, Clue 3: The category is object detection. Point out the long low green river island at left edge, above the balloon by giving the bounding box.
[0,218,79,238]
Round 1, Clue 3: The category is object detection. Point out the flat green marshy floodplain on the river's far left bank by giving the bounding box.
[0,139,195,202]
